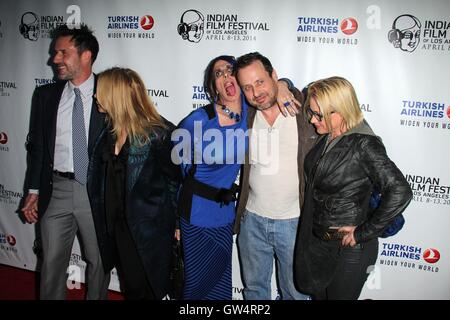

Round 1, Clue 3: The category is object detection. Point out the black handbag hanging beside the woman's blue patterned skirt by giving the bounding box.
[169,240,184,300]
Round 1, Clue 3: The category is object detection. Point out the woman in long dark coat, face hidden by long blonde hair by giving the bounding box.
[88,68,179,300]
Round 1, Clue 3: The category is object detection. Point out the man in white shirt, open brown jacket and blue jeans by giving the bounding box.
[235,52,317,300]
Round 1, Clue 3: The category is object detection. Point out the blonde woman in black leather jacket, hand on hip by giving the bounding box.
[295,77,412,300]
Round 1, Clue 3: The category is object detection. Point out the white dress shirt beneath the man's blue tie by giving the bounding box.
[53,74,94,172]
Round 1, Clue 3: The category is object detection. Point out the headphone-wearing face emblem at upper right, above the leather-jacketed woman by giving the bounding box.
[388,14,422,52]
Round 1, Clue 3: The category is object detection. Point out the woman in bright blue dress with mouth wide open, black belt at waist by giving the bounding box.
[172,55,298,300]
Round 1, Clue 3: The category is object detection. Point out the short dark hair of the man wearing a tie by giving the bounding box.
[50,24,99,63]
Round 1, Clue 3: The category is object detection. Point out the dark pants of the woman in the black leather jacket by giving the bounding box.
[314,238,378,300]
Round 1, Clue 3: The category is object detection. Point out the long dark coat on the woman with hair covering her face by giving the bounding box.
[88,121,180,299]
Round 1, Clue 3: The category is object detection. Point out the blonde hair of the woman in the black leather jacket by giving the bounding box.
[306,77,364,130]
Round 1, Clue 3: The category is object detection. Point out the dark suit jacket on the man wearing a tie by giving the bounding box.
[25,78,105,217]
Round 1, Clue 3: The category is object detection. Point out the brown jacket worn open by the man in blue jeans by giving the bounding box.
[234,88,317,234]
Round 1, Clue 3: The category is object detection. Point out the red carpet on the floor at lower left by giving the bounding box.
[0,264,124,300]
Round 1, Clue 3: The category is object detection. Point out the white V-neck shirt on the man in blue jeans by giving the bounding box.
[246,111,300,219]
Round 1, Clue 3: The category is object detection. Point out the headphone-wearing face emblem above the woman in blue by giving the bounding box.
[177,9,205,43]
